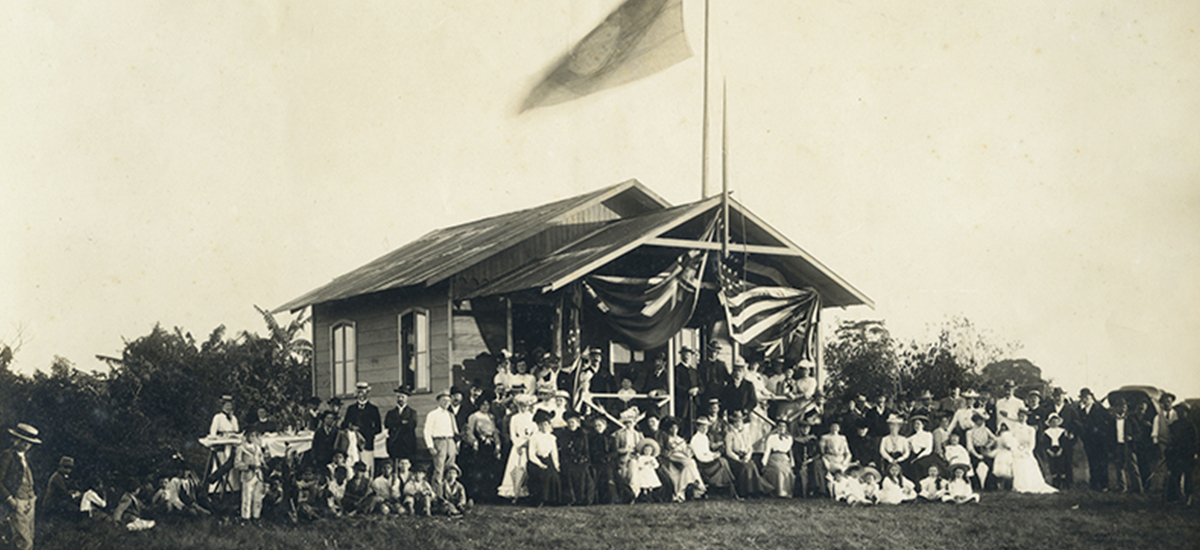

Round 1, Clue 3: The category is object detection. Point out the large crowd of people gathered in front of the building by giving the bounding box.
[0,342,1198,548]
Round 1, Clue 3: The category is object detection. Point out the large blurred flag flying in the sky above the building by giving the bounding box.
[521,0,691,113]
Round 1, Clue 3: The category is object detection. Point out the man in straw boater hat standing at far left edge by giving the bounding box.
[0,424,42,550]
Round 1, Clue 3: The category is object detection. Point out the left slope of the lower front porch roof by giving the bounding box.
[457,197,720,298]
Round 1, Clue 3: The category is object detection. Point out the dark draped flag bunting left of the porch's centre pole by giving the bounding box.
[581,217,715,349]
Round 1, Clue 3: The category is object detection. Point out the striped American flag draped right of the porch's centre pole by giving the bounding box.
[716,262,821,360]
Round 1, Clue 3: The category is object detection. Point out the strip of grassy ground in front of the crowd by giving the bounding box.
[37,491,1200,550]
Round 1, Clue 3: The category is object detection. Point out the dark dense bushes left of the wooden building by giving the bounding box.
[0,309,312,485]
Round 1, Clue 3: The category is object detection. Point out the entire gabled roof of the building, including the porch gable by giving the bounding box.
[275,180,875,312]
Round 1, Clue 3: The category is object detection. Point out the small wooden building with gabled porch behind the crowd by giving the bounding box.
[276,180,872,446]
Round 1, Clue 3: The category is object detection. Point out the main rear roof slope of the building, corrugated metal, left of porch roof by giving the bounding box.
[275,180,670,312]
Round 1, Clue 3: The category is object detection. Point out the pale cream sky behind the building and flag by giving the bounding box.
[0,0,1200,396]
